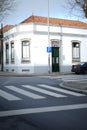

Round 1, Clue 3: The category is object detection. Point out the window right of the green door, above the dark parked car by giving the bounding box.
[72,42,80,60]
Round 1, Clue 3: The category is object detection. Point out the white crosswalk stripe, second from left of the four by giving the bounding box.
[5,86,45,99]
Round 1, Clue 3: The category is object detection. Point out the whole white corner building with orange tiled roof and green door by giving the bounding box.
[3,16,87,73]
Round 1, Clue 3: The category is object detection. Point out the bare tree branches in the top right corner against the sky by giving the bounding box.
[69,0,87,18]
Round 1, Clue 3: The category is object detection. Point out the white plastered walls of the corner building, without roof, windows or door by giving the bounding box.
[4,23,87,73]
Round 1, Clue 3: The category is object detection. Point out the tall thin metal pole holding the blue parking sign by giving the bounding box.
[48,0,50,73]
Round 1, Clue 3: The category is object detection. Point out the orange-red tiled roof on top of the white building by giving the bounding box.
[21,15,87,28]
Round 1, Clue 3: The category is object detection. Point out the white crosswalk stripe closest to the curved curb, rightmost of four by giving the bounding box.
[38,84,85,96]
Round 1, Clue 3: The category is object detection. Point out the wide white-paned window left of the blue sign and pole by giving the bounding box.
[22,41,30,62]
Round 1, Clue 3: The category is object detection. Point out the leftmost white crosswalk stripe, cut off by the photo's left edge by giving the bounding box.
[0,90,21,101]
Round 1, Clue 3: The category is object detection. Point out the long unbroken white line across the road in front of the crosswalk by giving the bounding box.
[0,103,87,117]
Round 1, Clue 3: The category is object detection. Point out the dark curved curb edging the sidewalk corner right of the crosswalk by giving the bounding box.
[59,83,87,94]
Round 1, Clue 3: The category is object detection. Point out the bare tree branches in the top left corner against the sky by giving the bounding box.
[0,0,15,20]
